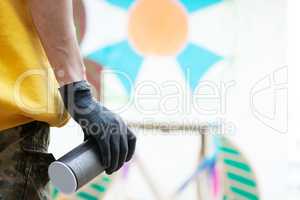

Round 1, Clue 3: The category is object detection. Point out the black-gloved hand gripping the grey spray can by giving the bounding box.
[59,81,136,174]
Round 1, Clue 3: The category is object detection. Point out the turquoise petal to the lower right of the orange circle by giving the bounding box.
[177,43,223,91]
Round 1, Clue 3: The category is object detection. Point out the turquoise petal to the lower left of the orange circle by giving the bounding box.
[87,41,143,94]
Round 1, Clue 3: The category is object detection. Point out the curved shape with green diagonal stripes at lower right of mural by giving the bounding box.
[217,137,260,200]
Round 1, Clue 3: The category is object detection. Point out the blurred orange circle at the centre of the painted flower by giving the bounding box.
[128,0,188,55]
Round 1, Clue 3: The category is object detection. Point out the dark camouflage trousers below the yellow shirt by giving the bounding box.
[0,121,54,200]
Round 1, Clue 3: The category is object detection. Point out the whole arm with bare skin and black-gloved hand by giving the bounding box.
[27,0,136,174]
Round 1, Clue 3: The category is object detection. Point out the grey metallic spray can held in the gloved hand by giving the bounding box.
[48,140,105,194]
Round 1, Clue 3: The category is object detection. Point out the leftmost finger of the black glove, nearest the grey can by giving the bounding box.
[105,135,120,174]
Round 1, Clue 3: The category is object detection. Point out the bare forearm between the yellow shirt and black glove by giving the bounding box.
[27,0,85,86]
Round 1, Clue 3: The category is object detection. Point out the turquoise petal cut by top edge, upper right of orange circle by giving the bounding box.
[180,0,223,13]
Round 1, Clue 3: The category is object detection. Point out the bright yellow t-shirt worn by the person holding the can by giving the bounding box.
[0,0,69,130]
